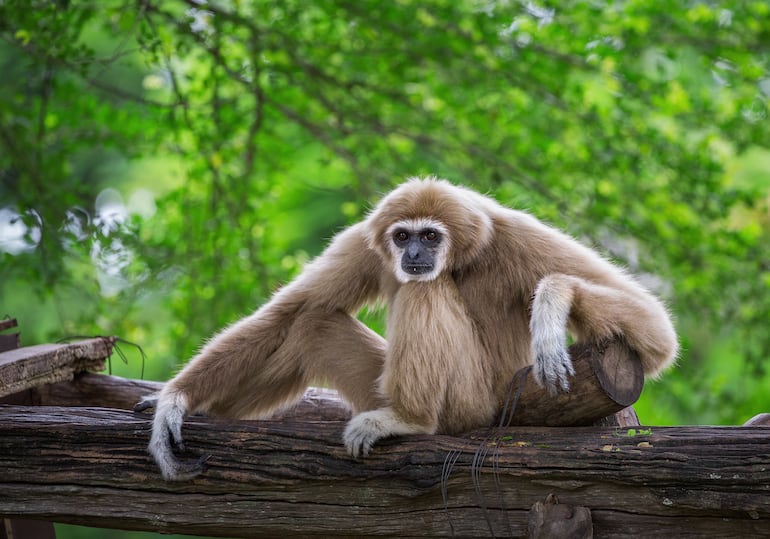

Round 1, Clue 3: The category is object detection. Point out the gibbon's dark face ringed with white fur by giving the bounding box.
[388,219,449,283]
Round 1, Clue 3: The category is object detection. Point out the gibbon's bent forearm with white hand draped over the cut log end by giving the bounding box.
[530,274,678,393]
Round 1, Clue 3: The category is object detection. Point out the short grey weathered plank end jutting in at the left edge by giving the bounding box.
[0,337,114,397]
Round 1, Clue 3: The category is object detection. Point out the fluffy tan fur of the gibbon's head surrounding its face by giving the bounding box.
[365,177,496,270]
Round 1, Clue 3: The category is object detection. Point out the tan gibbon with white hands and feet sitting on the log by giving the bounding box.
[139,178,677,480]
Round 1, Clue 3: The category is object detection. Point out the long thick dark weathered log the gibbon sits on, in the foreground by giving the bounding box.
[0,406,770,537]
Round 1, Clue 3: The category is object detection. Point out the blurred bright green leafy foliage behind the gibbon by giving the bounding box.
[0,0,770,537]
